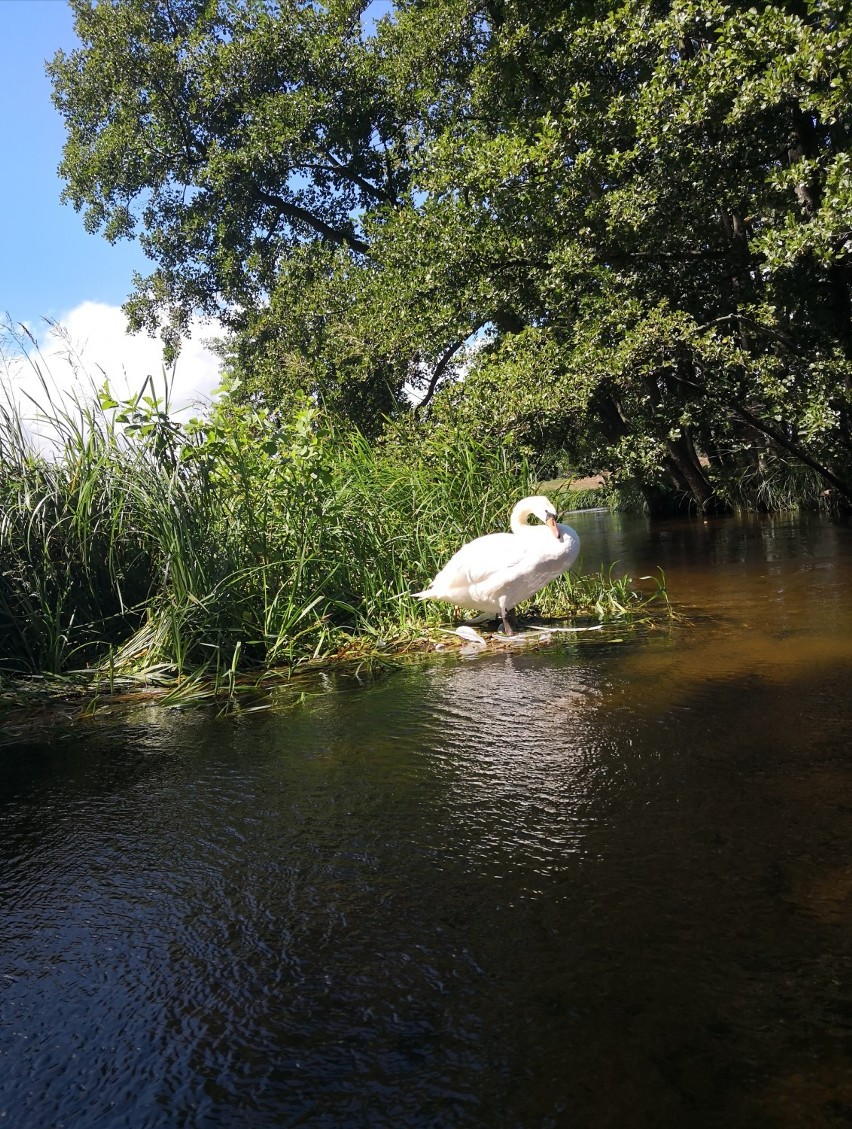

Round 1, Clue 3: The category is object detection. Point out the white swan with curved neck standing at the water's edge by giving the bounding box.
[414,495,580,634]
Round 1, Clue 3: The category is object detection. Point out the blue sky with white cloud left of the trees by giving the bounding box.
[0,0,219,419]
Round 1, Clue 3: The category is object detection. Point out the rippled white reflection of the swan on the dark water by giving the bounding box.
[419,655,600,875]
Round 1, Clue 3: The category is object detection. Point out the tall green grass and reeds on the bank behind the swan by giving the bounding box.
[0,370,668,704]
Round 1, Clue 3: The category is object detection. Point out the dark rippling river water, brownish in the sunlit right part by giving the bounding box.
[0,513,852,1129]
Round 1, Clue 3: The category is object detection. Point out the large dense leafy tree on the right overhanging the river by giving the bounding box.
[379,3,852,509]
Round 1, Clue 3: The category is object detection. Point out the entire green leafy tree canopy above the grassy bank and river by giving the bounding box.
[50,0,852,509]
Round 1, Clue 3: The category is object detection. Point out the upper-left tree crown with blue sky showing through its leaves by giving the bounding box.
[49,0,402,326]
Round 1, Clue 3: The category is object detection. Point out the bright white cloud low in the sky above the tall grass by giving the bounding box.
[0,301,221,426]
